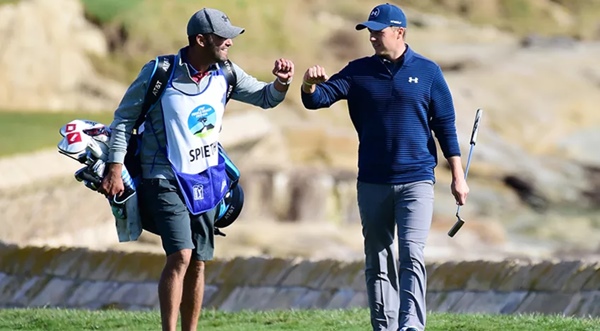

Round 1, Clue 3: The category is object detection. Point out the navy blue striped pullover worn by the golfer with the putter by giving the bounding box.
[302,46,460,184]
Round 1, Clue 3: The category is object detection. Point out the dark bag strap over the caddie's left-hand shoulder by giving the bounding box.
[134,54,175,130]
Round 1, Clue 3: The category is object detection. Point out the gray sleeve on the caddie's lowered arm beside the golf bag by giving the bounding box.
[107,60,155,163]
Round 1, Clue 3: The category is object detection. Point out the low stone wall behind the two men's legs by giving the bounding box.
[0,246,600,316]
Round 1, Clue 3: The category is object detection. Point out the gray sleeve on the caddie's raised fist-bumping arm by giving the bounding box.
[231,63,286,109]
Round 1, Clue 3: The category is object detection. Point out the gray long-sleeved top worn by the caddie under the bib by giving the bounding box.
[108,51,286,179]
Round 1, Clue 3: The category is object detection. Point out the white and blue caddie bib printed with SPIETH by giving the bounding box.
[161,71,229,215]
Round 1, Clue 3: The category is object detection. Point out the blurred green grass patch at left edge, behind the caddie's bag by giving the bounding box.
[0,111,112,157]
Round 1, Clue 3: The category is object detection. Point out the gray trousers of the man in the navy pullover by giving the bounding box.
[357,180,434,331]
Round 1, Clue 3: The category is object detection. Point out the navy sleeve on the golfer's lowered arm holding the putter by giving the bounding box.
[429,67,460,158]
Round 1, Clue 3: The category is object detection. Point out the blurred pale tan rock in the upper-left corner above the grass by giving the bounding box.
[0,0,125,110]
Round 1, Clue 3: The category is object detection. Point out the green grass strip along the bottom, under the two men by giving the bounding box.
[0,309,600,331]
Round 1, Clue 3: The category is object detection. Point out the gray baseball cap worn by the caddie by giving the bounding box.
[187,8,244,39]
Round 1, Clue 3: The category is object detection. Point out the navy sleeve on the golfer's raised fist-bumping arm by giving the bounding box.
[300,66,351,110]
